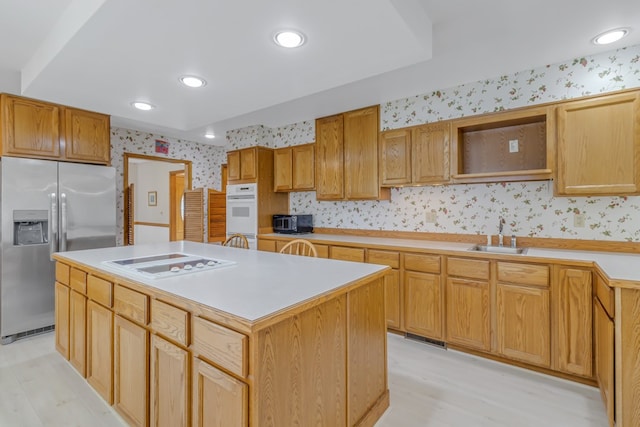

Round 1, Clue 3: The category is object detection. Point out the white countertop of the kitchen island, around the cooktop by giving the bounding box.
[57,241,386,321]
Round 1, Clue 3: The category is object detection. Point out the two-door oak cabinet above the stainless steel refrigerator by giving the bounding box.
[0,94,111,164]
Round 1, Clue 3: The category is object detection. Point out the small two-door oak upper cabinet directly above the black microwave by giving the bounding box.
[273,143,316,191]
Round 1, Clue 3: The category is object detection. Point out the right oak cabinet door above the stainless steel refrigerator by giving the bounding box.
[64,108,111,164]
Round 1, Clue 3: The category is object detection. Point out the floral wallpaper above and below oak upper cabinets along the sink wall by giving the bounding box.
[227,45,640,242]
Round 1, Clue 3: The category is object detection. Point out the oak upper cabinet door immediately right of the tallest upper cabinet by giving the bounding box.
[380,129,411,186]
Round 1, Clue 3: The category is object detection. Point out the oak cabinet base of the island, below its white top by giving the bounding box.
[54,243,391,427]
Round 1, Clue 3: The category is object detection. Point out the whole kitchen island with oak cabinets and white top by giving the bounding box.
[54,242,389,426]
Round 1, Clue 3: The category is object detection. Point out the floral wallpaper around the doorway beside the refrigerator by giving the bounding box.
[111,128,227,245]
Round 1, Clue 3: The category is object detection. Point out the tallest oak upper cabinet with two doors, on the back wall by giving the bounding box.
[316,105,389,200]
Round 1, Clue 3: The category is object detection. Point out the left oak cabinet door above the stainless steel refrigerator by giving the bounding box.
[1,95,60,158]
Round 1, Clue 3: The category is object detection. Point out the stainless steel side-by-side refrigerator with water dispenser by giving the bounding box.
[0,157,116,344]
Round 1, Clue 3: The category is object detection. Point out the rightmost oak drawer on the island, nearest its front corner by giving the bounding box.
[192,317,249,377]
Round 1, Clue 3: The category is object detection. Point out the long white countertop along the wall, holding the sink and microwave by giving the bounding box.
[264,233,640,283]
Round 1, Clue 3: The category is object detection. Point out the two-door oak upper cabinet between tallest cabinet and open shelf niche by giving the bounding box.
[380,122,451,187]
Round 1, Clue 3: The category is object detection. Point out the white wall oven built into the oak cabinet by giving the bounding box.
[227,184,258,249]
